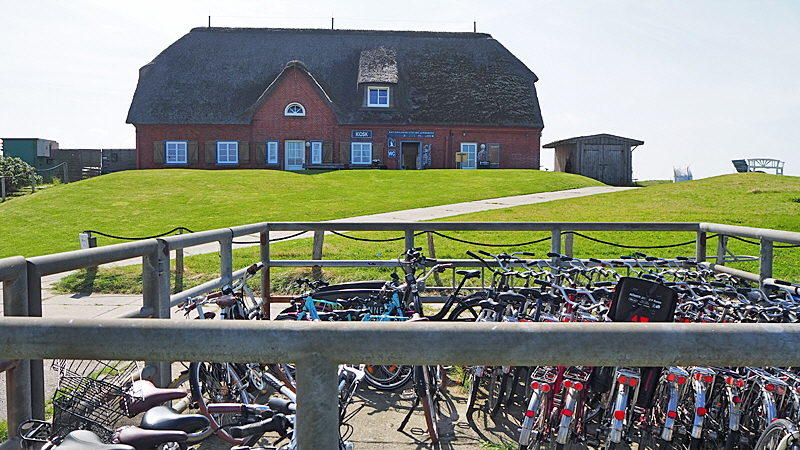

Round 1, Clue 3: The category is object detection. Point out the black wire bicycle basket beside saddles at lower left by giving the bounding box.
[50,360,139,443]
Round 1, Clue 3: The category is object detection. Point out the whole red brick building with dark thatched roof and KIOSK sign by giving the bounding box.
[127,28,544,170]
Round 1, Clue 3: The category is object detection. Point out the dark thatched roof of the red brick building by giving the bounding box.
[127,28,544,127]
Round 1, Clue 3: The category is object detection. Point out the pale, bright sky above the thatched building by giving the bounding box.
[0,0,800,180]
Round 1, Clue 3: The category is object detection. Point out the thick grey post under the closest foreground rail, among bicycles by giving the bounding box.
[295,353,339,450]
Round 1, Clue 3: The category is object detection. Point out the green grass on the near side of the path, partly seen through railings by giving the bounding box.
[53,173,800,292]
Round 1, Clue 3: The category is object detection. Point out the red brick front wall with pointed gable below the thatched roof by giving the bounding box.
[136,68,541,169]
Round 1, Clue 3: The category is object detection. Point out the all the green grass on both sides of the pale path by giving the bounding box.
[39,170,800,291]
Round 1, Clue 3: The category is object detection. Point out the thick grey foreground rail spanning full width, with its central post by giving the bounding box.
[0,317,800,450]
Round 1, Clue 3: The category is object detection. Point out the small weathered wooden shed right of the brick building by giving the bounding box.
[542,134,644,186]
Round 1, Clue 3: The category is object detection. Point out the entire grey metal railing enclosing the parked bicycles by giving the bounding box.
[0,222,800,450]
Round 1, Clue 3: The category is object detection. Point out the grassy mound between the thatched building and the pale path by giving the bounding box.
[0,170,602,258]
